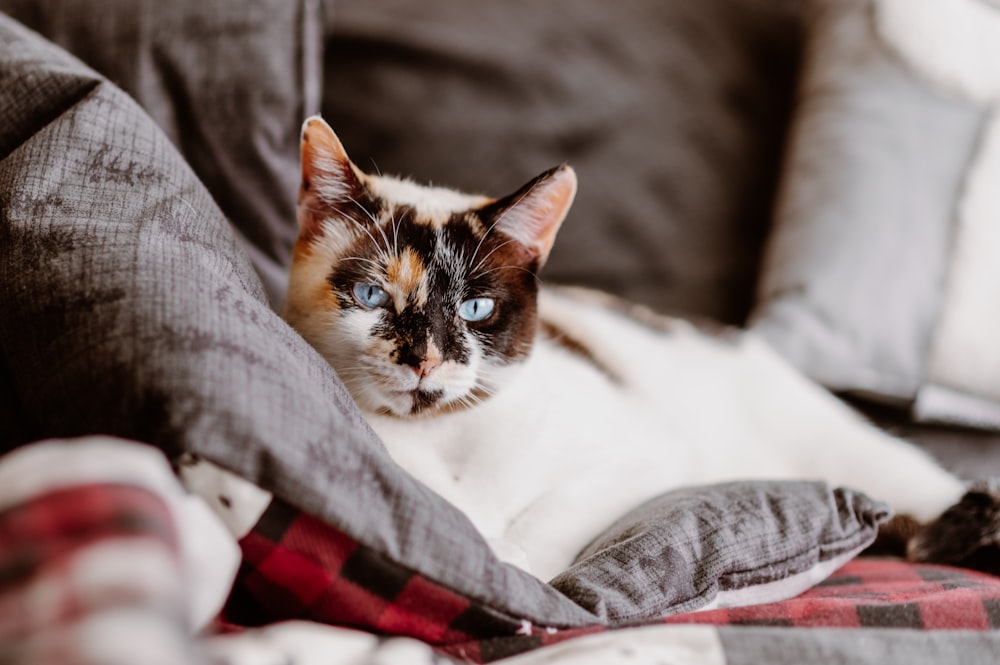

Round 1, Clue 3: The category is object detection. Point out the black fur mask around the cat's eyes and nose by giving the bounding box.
[328,200,538,378]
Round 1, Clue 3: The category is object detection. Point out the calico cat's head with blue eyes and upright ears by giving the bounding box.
[284,118,576,416]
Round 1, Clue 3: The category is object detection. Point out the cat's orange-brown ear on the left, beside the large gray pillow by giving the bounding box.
[298,116,364,238]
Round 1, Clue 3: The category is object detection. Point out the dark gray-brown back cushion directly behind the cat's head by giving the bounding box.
[323,0,806,323]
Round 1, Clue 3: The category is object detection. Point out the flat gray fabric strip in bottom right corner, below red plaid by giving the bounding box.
[719,626,1000,665]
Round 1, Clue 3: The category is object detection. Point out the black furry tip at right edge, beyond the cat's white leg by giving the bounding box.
[907,479,1000,575]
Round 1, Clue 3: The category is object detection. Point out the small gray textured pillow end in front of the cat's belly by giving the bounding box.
[551,481,890,624]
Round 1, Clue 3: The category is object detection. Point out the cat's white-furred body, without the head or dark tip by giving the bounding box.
[370,291,963,579]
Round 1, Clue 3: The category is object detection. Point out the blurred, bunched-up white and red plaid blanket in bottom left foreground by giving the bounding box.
[0,437,237,665]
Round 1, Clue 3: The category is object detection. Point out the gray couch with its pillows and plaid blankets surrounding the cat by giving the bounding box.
[0,0,1000,664]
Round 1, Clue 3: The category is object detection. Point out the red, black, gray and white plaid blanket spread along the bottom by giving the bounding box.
[0,440,1000,665]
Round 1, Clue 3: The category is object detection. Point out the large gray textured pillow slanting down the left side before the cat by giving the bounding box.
[0,15,594,625]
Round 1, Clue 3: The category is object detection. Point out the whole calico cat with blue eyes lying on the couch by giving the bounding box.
[284,117,1000,579]
